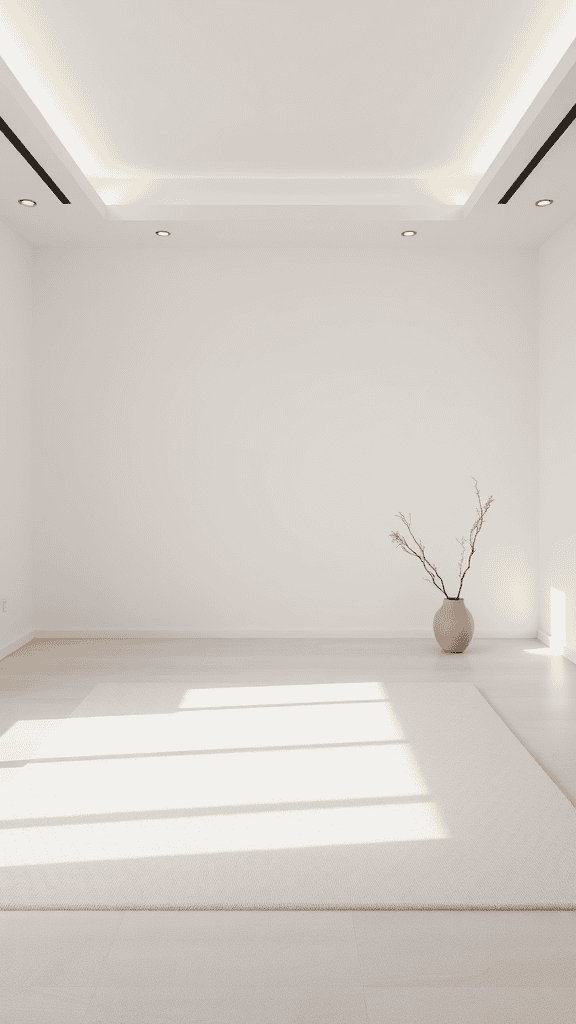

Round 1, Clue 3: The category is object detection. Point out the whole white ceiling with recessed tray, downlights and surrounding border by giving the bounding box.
[0,0,576,248]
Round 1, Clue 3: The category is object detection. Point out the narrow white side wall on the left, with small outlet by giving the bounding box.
[0,221,34,657]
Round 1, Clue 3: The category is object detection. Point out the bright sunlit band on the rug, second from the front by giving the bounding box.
[2,743,427,820]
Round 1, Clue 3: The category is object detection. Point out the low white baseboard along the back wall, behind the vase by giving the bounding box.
[34,629,536,640]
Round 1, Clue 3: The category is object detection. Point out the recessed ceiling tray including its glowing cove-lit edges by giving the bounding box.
[0,0,576,206]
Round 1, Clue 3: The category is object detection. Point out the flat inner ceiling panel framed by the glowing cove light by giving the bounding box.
[5,0,550,177]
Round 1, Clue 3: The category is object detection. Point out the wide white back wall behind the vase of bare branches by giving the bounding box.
[34,243,538,637]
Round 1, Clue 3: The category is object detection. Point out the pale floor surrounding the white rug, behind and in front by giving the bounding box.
[0,640,576,1024]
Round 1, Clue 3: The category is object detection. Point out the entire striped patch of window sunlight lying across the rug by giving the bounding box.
[0,682,448,866]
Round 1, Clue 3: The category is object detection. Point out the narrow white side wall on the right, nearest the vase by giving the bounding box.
[539,219,576,660]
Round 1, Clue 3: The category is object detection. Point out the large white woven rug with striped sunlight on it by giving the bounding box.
[0,671,576,909]
